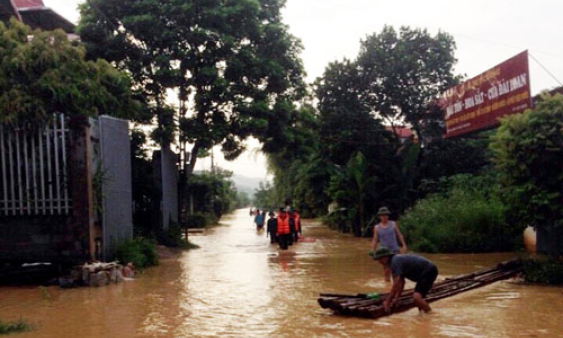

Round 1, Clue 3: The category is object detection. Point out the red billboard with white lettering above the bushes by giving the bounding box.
[441,51,532,137]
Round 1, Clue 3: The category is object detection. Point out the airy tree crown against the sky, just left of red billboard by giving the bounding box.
[357,26,459,143]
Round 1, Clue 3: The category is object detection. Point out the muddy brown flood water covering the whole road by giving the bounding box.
[0,210,563,338]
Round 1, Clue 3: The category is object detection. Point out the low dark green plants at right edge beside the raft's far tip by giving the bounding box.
[524,258,563,285]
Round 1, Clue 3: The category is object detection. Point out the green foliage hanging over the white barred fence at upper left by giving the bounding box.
[0,19,141,128]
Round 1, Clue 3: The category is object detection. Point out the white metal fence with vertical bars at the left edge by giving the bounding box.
[0,114,71,216]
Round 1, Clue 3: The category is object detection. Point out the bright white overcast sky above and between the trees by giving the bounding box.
[44,0,563,178]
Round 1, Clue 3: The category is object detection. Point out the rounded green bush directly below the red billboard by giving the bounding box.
[399,175,521,253]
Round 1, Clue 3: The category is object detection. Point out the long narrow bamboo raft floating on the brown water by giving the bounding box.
[318,260,522,318]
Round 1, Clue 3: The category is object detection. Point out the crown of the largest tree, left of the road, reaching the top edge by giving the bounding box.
[79,0,303,176]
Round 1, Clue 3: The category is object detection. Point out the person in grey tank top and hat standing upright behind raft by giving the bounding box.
[371,207,407,282]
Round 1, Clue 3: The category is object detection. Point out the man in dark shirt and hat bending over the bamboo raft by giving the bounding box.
[373,246,438,312]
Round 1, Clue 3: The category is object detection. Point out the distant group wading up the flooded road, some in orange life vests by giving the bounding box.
[250,206,303,250]
